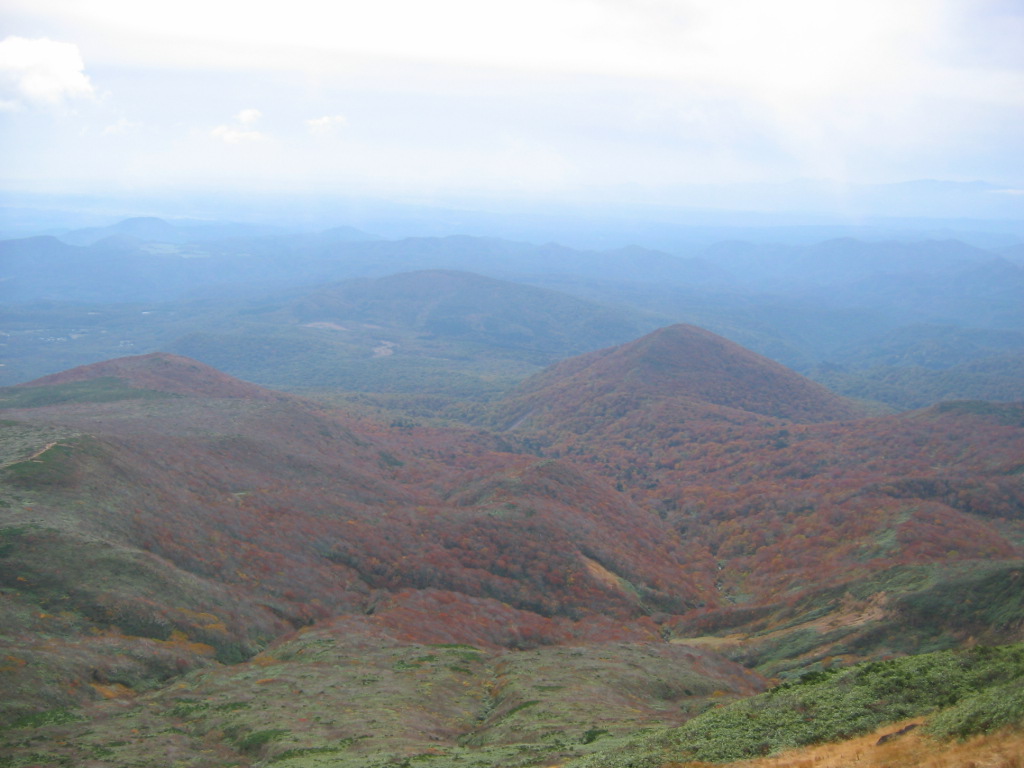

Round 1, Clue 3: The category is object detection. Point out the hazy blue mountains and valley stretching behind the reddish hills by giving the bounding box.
[6,218,1024,408]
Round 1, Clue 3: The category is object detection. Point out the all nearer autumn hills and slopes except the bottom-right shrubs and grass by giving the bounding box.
[0,333,1024,768]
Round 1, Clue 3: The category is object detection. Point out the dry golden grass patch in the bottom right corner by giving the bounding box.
[672,720,1024,768]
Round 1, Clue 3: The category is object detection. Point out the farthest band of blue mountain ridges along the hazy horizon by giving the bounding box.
[8,218,1019,301]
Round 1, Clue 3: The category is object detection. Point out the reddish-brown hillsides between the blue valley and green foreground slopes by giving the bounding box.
[0,348,1024,745]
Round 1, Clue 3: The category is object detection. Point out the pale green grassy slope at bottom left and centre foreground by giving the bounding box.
[0,617,758,768]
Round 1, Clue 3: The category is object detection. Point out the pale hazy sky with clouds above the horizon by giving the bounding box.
[0,0,1024,205]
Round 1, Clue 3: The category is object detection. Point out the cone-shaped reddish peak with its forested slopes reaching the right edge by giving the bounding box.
[495,327,1022,634]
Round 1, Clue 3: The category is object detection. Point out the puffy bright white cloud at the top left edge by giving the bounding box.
[0,36,94,110]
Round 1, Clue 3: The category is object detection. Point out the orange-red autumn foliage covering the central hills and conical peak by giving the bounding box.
[9,350,1024,654]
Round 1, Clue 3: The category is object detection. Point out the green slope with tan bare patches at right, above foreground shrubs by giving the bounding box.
[673,561,1024,679]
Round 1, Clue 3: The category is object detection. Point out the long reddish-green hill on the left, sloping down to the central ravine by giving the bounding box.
[2,355,720,720]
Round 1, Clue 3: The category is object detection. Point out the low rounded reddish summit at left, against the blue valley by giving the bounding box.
[19,352,284,399]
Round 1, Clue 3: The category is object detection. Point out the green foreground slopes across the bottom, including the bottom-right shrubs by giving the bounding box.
[0,638,1024,768]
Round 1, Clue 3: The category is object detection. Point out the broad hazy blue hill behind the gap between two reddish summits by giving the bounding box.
[164,270,658,393]
